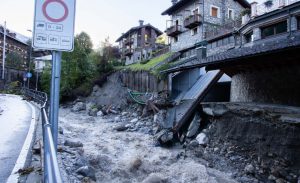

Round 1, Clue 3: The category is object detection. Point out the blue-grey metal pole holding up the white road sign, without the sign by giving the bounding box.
[50,51,62,151]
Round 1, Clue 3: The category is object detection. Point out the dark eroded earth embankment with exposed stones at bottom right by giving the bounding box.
[198,103,300,183]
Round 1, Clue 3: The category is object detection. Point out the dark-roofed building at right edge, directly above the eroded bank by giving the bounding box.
[166,0,300,106]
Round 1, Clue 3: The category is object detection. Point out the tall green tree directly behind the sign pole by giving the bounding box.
[42,32,96,98]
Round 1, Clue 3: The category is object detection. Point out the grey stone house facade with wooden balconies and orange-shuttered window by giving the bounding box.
[162,0,250,51]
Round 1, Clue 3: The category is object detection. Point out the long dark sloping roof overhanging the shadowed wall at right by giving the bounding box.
[163,32,300,73]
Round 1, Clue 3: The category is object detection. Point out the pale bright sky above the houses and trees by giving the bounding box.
[0,0,263,48]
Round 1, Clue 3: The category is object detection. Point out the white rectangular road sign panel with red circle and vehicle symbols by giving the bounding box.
[32,0,76,51]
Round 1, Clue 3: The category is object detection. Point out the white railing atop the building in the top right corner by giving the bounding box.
[256,0,300,16]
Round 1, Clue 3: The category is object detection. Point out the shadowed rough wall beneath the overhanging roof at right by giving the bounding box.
[231,65,300,106]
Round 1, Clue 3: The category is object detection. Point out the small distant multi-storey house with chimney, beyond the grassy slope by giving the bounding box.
[116,20,162,65]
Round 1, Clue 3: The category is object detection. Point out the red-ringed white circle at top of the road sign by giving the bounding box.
[42,0,69,23]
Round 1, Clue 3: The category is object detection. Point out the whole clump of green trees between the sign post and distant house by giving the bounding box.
[41,32,119,99]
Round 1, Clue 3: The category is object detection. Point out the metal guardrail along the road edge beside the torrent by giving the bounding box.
[22,88,62,183]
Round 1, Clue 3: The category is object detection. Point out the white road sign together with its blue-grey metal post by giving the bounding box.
[32,0,76,153]
